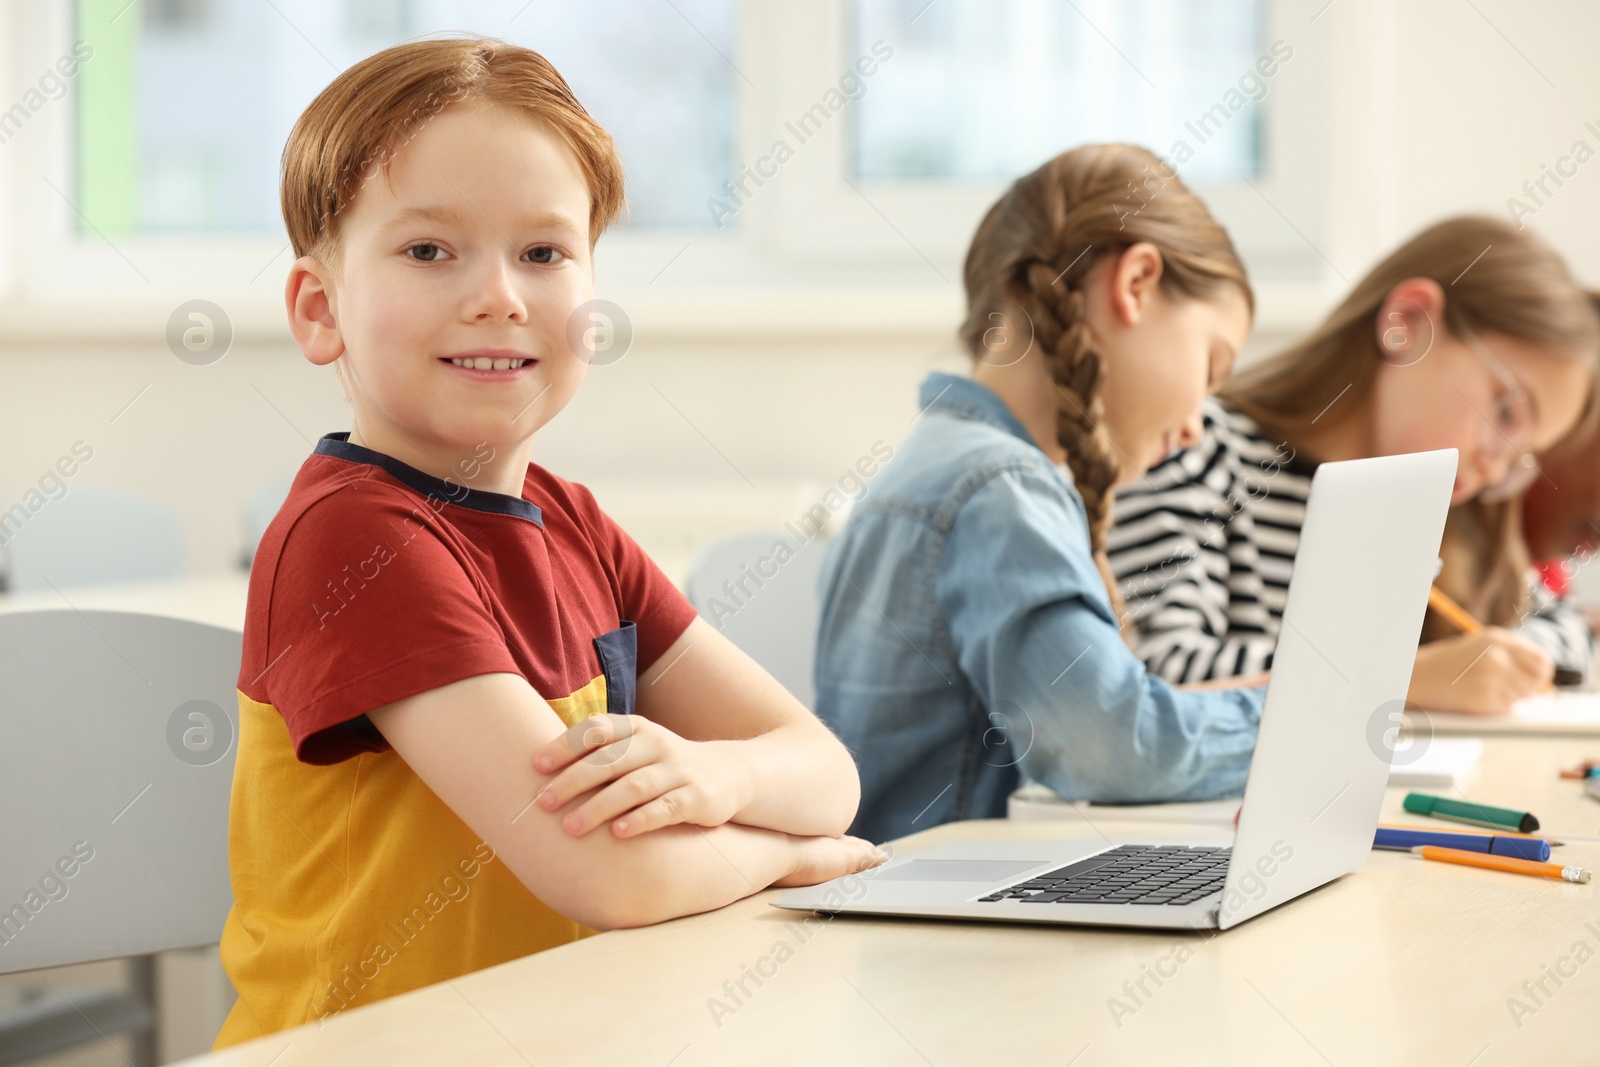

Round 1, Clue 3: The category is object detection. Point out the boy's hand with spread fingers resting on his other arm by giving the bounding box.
[533,715,750,837]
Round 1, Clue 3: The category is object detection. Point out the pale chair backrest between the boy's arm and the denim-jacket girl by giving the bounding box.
[686,530,826,707]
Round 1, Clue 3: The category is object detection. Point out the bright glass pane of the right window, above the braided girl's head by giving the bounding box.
[850,0,1277,184]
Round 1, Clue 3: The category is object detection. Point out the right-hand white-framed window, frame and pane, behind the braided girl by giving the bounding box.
[726,0,1331,290]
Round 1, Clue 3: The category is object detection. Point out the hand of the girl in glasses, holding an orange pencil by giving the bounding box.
[1406,625,1555,715]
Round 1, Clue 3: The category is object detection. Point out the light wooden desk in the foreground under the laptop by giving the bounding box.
[175,739,1600,1067]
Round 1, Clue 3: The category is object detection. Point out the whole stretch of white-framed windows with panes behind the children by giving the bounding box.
[0,0,1333,315]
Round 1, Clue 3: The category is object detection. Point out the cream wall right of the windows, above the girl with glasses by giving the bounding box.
[1318,0,1600,282]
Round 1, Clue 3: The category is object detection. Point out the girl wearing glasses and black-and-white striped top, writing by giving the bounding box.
[1107,218,1600,712]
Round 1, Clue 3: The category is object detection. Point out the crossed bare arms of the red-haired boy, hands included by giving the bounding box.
[370,621,882,929]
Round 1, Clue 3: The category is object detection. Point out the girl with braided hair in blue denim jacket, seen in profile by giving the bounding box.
[816,144,1262,841]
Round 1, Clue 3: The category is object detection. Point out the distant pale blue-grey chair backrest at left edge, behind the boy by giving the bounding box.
[0,485,189,592]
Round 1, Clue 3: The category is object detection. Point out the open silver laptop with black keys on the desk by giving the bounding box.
[774,448,1456,929]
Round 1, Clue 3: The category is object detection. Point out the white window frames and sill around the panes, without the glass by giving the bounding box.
[0,0,1334,333]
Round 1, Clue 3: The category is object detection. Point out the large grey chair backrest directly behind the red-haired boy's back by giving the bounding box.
[0,611,242,974]
